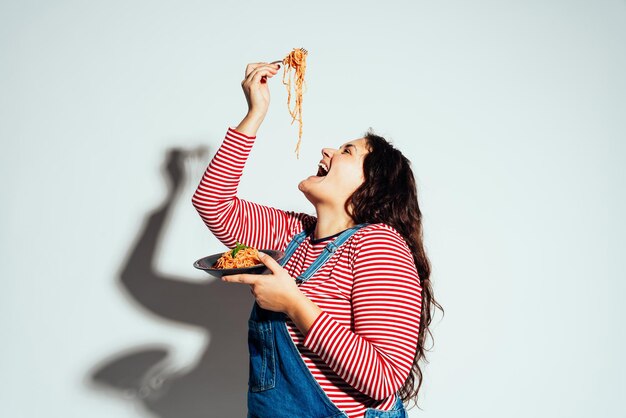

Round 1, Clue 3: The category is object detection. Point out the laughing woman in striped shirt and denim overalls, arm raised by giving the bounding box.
[192,63,439,418]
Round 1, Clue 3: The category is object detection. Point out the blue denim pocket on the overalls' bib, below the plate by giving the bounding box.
[248,319,276,392]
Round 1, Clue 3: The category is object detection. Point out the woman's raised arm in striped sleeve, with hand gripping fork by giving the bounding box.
[192,63,315,250]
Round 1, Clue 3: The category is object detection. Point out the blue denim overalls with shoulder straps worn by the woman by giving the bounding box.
[248,224,408,418]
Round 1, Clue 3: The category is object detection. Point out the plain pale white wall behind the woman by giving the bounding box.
[0,0,626,418]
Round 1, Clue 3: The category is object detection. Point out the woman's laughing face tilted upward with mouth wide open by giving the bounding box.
[298,138,369,207]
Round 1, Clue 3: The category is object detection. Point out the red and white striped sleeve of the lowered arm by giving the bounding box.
[304,227,421,400]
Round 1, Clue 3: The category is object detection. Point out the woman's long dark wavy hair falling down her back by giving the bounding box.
[346,128,443,409]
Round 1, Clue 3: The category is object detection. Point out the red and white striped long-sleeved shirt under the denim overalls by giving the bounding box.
[192,128,422,418]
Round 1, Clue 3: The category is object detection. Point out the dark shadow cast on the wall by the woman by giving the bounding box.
[84,145,253,418]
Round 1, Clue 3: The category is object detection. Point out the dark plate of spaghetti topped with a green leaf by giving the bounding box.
[193,243,284,277]
